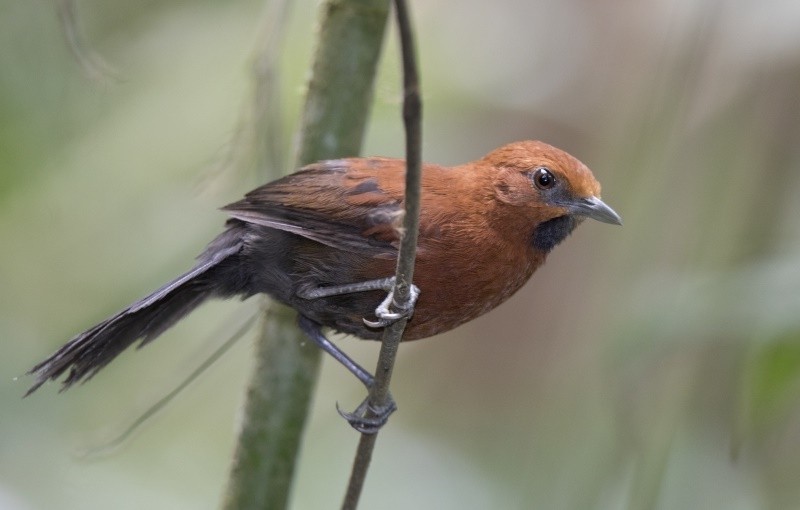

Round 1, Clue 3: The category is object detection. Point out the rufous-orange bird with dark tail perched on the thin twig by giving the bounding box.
[26,140,622,429]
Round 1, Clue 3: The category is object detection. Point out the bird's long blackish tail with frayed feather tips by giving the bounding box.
[25,228,247,396]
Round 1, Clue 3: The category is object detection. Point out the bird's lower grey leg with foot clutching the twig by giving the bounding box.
[297,315,397,434]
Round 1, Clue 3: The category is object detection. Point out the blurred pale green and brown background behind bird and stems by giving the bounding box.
[0,0,800,510]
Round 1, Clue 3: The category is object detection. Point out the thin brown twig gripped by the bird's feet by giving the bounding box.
[342,0,422,510]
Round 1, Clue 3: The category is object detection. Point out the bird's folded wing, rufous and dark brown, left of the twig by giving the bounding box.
[222,158,404,258]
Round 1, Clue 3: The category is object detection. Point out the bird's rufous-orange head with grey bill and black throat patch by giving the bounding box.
[483,141,622,252]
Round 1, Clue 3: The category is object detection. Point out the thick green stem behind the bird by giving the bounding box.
[223,0,389,510]
